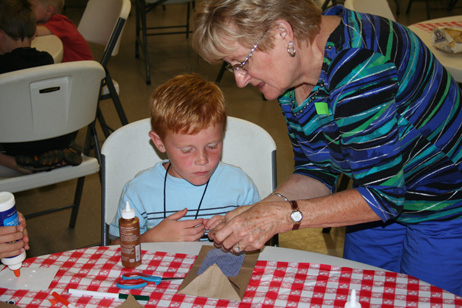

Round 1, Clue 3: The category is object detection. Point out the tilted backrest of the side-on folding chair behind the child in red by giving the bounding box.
[78,0,131,57]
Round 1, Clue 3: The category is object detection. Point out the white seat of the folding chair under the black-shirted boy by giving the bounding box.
[0,155,99,193]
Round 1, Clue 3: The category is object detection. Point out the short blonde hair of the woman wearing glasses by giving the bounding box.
[192,0,321,63]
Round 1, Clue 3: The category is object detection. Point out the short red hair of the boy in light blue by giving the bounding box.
[150,73,226,140]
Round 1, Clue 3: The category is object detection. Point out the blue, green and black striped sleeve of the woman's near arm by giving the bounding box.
[329,49,406,221]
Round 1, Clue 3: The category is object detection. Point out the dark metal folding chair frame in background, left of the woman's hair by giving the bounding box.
[134,0,195,85]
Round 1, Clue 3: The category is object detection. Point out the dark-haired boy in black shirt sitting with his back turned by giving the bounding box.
[0,0,82,174]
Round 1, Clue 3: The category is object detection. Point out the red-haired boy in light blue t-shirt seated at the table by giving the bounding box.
[109,74,260,244]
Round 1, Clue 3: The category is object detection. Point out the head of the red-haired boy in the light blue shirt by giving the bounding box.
[149,74,226,185]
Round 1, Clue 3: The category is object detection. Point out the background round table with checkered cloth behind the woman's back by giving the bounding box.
[408,15,462,83]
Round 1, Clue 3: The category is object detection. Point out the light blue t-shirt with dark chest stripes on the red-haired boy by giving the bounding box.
[109,161,260,238]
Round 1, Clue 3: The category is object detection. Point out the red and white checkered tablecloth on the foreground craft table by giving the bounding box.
[0,246,462,308]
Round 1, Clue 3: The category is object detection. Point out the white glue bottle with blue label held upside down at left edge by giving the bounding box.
[0,191,26,277]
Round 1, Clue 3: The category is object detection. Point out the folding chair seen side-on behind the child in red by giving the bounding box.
[78,0,131,137]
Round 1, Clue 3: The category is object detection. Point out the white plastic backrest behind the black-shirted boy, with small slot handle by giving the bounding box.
[0,61,105,143]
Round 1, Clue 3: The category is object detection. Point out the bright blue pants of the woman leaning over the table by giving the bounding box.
[343,219,462,296]
